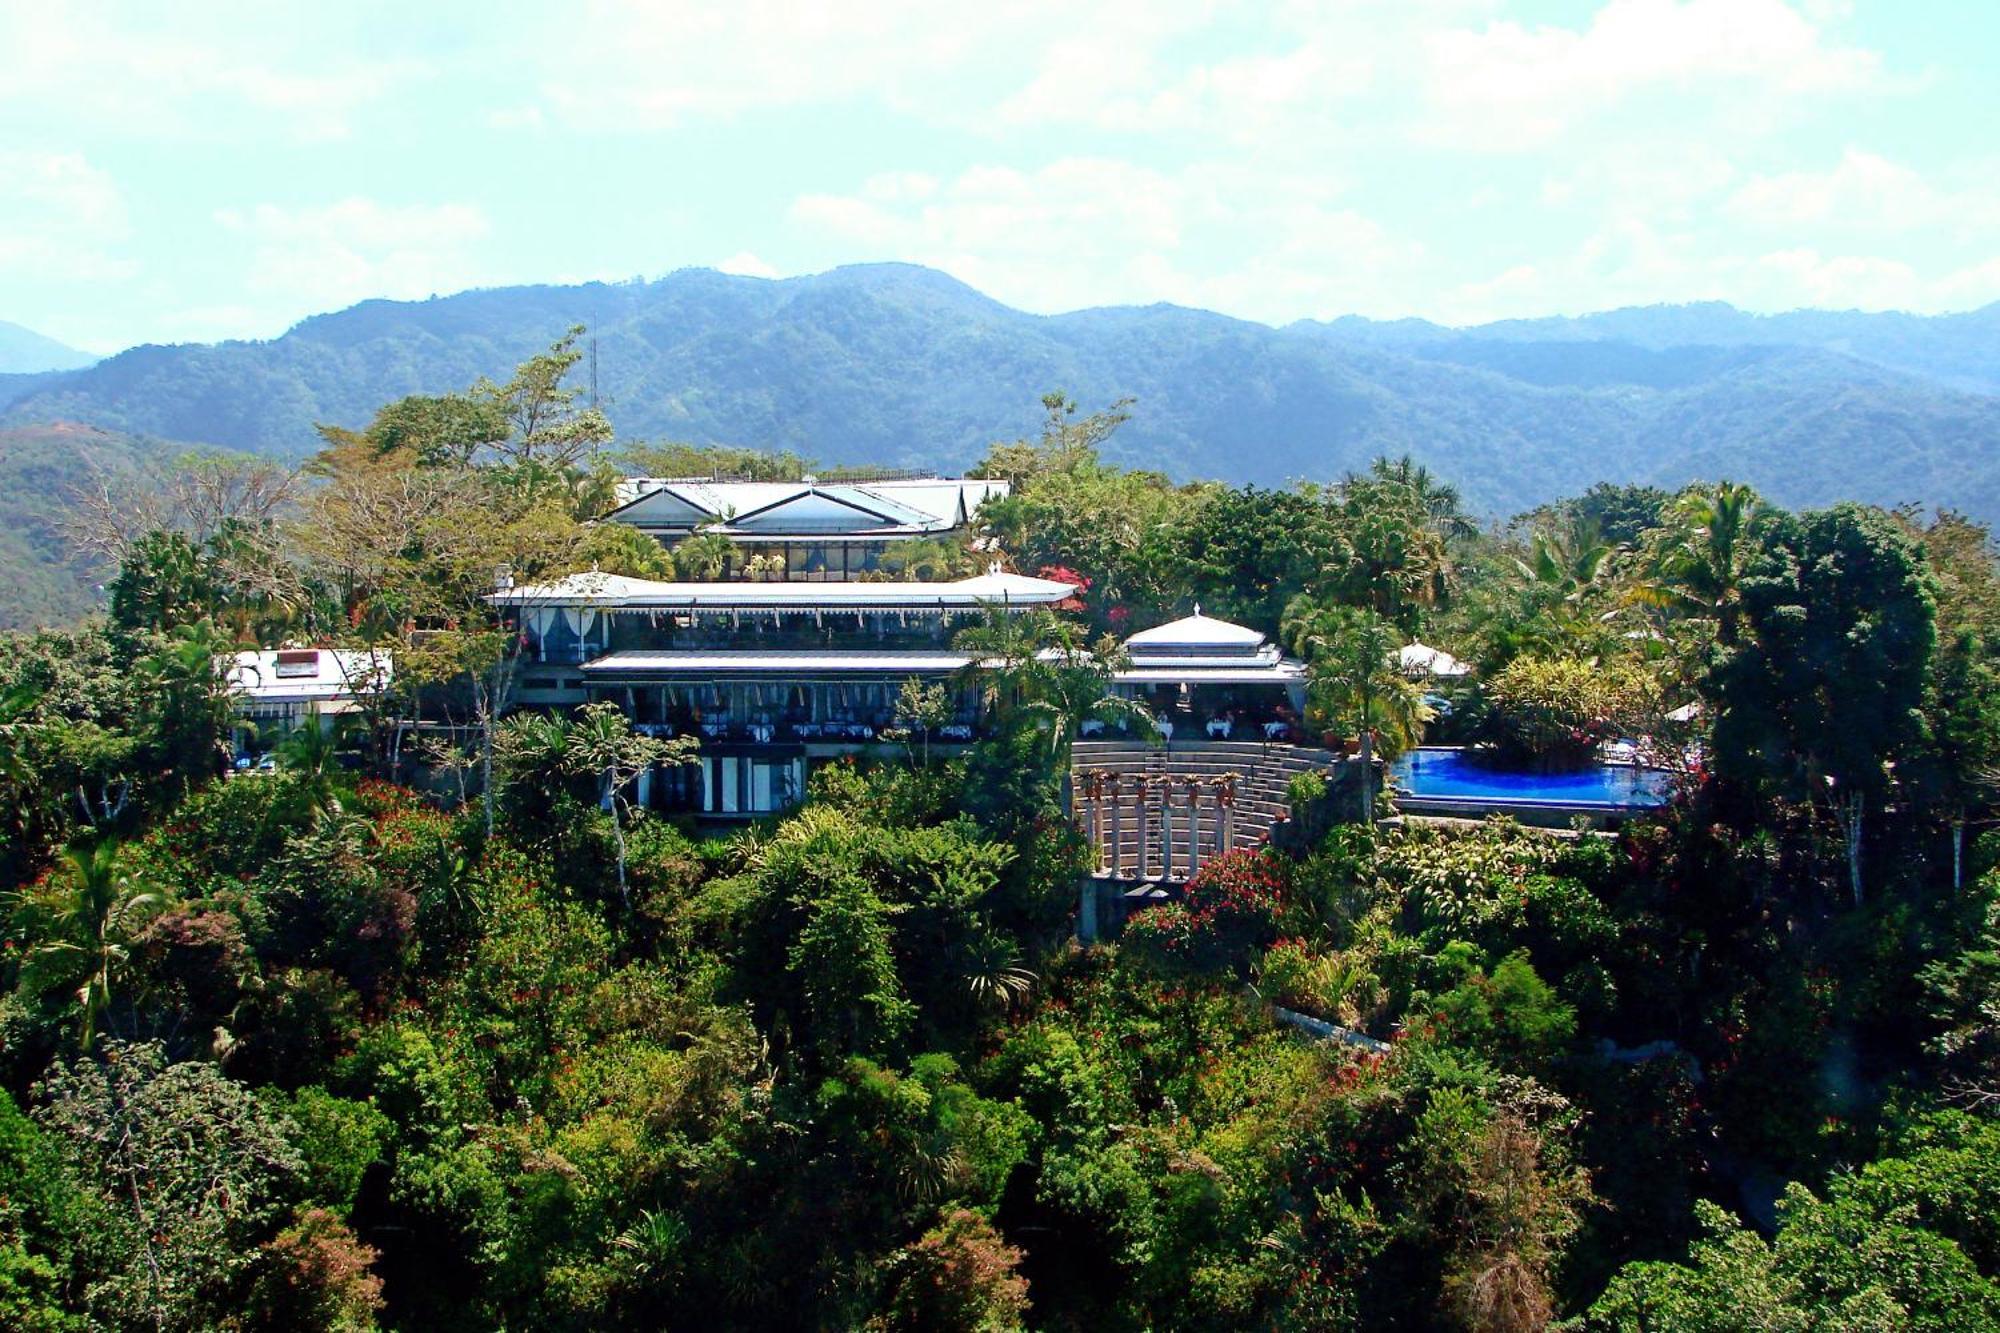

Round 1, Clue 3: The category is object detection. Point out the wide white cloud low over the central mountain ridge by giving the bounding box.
[792,158,1424,320]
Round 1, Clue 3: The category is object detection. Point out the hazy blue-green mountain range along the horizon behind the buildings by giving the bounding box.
[0,264,2000,618]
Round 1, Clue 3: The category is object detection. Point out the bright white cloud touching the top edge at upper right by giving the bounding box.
[1424,0,1880,150]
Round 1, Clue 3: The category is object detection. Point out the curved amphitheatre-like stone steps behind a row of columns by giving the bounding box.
[1070,741,1340,883]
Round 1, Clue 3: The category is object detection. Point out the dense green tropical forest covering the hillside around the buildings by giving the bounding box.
[0,336,2000,1331]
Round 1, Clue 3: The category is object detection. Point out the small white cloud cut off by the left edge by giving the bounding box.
[0,150,138,282]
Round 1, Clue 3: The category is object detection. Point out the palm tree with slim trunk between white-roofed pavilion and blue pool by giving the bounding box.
[1282,594,1432,825]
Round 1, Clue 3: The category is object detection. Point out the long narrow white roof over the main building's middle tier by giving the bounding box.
[486,566,1076,612]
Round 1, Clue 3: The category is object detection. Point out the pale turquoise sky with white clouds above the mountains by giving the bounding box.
[0,0,2000,352]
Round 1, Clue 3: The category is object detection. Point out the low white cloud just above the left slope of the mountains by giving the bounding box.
[214,198,490,310]
